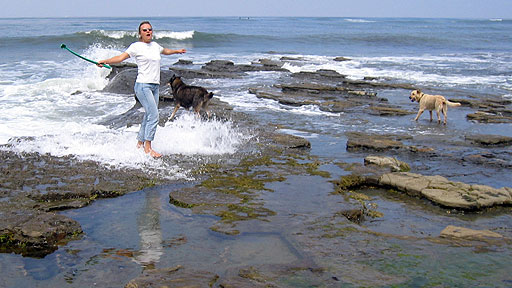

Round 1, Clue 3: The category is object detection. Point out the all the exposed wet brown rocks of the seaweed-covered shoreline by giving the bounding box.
[0,58,512,287]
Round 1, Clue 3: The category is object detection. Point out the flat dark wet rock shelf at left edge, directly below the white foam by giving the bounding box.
[0,150,157,201]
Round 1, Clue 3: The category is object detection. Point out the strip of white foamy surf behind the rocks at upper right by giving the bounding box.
[283,55,510,88]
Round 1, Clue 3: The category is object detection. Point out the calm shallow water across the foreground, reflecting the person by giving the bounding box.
[0,166,512,287]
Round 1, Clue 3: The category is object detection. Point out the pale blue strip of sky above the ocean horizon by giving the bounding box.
[0,0,512,19]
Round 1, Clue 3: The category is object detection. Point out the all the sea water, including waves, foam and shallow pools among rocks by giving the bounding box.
[0,17,512,287]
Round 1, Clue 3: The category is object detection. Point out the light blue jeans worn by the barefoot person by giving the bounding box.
[134,82,160,142]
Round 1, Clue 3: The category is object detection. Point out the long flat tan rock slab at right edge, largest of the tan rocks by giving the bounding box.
[379,172,512,210]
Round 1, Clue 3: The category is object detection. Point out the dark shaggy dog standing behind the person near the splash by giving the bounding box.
[169,75,213,120]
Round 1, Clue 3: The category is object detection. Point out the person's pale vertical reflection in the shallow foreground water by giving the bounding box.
[133,189,163,267]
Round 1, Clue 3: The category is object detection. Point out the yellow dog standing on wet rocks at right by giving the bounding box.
[409,90,460,125]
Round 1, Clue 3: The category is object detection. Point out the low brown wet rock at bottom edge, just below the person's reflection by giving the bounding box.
[124,265,219,288]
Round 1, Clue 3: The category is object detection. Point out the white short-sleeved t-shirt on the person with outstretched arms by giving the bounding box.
[126,41,164,84]
